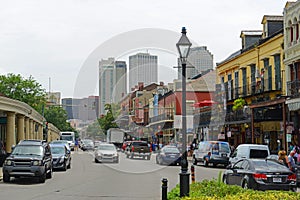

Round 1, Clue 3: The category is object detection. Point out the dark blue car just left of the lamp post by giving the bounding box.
[156,145,181,165]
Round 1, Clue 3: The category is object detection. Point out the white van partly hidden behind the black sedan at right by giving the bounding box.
[229,144,270,164]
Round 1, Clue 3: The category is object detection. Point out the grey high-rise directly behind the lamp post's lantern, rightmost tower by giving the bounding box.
[178,46,214,79]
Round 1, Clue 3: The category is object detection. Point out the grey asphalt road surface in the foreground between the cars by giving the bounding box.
[0,151,224,200]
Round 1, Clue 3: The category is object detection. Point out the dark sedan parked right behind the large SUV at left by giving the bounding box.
[50,144,71,171]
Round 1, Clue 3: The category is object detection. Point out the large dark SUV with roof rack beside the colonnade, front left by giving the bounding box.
[2,140,52,183]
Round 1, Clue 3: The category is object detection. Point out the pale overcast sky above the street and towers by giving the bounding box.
[0,0,286,98]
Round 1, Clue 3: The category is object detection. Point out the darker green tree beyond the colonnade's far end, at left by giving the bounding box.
[44,106,75,131]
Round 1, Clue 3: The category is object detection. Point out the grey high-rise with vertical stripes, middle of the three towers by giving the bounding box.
[129,53,158,89]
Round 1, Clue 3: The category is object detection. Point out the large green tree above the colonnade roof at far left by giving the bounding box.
[0,73,46,114]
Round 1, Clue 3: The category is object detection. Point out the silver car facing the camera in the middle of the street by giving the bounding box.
[95,143,119,163]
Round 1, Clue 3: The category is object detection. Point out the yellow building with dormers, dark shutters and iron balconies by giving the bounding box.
[216,15,286,152]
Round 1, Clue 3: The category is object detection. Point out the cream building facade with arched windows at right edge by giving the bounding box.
[284,1,300,145]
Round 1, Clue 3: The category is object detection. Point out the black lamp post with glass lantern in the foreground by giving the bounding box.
[176,27,192,197]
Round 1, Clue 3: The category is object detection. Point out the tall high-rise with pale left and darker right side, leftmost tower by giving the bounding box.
[99,58,127,114]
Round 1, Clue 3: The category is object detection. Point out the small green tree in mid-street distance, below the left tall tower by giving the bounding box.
[98,104,118,134]
